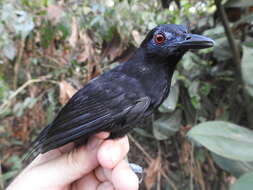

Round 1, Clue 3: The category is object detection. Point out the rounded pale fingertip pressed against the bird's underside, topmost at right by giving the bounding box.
[97,136,129,168]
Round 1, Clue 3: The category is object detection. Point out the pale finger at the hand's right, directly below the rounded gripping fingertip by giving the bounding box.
[112,160,139,190]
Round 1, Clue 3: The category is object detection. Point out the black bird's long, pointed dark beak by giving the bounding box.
[178,34,214,49]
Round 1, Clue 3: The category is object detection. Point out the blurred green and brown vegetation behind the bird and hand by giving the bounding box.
[0,0,253,190]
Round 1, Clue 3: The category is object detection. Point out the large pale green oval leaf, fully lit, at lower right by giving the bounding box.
[187,121,253,161]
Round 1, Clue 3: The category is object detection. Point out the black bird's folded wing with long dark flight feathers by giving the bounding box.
[28,80,150,156]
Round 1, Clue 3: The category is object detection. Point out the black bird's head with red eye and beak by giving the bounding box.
[141,24,214,59]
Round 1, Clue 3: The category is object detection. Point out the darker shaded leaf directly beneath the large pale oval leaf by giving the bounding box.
[211,153,253,177]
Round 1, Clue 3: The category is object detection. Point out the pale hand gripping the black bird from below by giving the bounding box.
[6,132,138,190]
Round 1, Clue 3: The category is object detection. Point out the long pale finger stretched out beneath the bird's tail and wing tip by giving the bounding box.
[17,137,102,187]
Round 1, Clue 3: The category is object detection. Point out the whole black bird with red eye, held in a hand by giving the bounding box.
[27,24,214,156]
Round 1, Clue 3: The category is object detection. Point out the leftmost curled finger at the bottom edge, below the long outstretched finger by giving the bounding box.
[72,173,99,190]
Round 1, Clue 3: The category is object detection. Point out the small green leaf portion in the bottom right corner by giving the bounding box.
[230,172,253,190]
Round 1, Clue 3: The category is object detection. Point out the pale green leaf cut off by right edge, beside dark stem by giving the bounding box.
[241,46,253,96]
